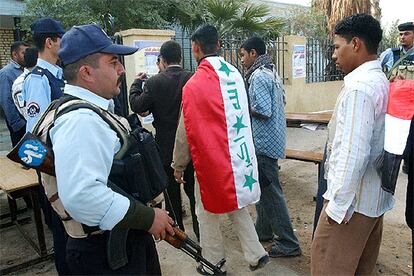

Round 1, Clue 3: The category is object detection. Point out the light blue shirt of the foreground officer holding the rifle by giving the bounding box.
[50,85,130,230]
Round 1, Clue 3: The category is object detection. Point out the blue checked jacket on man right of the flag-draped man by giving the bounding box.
[249,67,286,159]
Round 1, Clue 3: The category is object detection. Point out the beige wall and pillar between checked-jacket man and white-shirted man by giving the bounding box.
[284,36,343,112]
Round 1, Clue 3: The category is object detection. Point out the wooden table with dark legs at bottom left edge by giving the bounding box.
[0,156,53,274]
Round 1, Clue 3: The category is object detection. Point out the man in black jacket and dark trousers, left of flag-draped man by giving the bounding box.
[129,40,199,239]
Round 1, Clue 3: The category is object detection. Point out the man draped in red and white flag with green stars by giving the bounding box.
[172,25,269,275]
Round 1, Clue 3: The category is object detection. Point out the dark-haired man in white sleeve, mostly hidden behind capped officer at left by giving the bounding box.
[12,47,38,120]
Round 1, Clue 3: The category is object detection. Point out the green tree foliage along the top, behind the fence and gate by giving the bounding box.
[23,0,283,37]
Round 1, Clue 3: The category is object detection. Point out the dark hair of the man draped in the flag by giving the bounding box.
[191,24,219,55]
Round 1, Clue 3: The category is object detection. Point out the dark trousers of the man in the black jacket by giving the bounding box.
[164,162,200,240]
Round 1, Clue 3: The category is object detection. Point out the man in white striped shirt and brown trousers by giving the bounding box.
[311,14,394,275]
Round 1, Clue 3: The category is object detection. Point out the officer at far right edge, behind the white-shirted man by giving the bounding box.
[380,22,414,71]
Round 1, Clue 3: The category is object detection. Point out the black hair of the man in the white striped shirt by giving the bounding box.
[335,13,382,54]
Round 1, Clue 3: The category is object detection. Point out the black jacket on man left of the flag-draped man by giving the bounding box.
[129,66,192,166]
